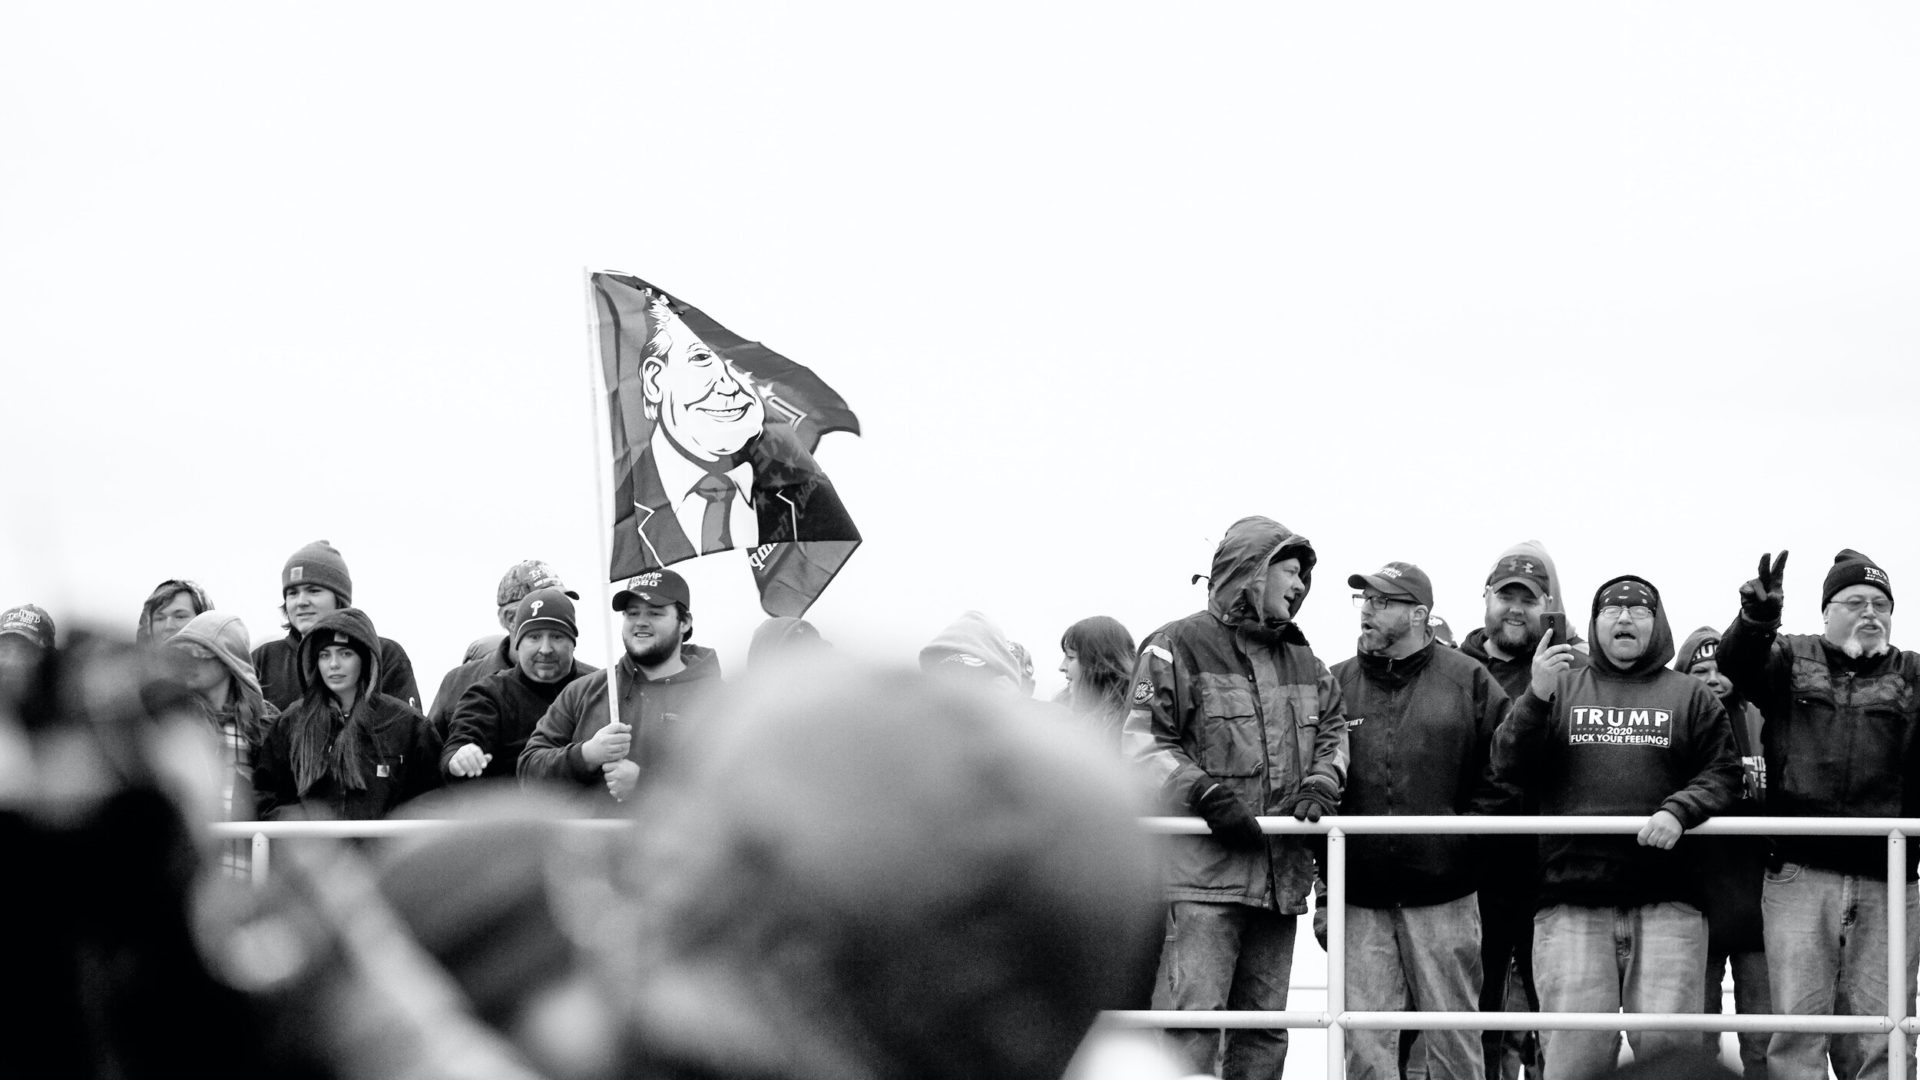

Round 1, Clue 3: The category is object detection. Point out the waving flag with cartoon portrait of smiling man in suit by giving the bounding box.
[588,273,860,617]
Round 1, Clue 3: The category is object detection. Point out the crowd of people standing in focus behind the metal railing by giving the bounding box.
[0,517,1920,1080]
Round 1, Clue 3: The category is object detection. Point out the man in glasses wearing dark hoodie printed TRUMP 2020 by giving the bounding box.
[1494,577,1741,1080]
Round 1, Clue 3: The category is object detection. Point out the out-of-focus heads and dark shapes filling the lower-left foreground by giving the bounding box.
[0,638,1156,1080]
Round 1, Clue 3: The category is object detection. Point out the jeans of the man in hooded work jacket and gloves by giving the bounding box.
[1154,899,1298,1080]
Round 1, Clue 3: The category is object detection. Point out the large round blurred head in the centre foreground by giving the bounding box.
[628,655,1158,1080]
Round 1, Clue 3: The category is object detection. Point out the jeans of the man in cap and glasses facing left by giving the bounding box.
[1346,894,1486,1080]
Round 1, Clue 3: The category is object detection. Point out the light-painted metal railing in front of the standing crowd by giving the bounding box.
[213,817,1920,1080]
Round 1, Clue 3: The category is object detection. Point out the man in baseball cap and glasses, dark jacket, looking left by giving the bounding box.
[1332,563,1507,1080]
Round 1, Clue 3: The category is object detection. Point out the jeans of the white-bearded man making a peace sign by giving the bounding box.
[1761,863,1920,1080]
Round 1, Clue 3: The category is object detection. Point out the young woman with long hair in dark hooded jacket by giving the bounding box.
[253,607,440,821]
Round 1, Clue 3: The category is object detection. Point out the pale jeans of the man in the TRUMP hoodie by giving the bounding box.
[1534,903,1707,1080]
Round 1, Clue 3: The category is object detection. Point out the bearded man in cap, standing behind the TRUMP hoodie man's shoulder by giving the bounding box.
[1459,540,1586,1080]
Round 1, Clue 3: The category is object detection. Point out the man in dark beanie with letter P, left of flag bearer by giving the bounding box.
[440,588,599,780]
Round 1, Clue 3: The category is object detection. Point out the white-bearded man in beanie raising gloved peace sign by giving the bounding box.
[1718,548,1920,1080]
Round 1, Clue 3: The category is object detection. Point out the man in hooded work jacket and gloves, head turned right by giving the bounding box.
[1121,517,1346,1080]
